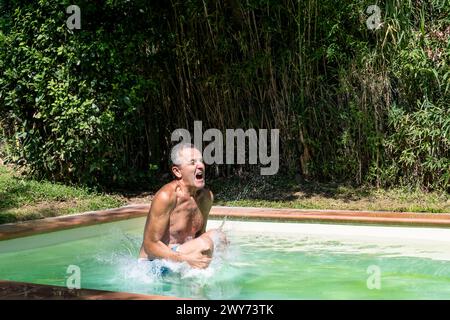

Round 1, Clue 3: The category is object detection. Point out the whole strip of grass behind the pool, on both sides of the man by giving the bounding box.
[0,165,450,224]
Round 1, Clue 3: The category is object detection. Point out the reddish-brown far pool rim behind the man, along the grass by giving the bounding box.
[0,204,450,241]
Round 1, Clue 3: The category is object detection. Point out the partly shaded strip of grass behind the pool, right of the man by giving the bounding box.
[211,176,450,213]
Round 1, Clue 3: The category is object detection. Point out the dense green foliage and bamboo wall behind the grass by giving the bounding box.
[0,0,450,190]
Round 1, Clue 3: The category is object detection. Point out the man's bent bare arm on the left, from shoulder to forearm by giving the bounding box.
[144,191,183,261]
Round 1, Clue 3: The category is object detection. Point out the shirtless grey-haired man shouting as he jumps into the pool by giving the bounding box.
[139,143,226,268]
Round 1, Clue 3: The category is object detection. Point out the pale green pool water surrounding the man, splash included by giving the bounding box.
[0,218,450,299]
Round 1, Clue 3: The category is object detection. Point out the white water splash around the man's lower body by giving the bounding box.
[90,226,240,299]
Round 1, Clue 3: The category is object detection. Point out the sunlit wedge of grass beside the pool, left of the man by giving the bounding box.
[0,165,126,224]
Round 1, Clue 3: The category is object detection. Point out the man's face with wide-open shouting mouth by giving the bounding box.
[177,148,205,189]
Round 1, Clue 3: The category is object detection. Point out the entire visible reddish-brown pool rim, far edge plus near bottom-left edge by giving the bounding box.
[0,204,450,300]
